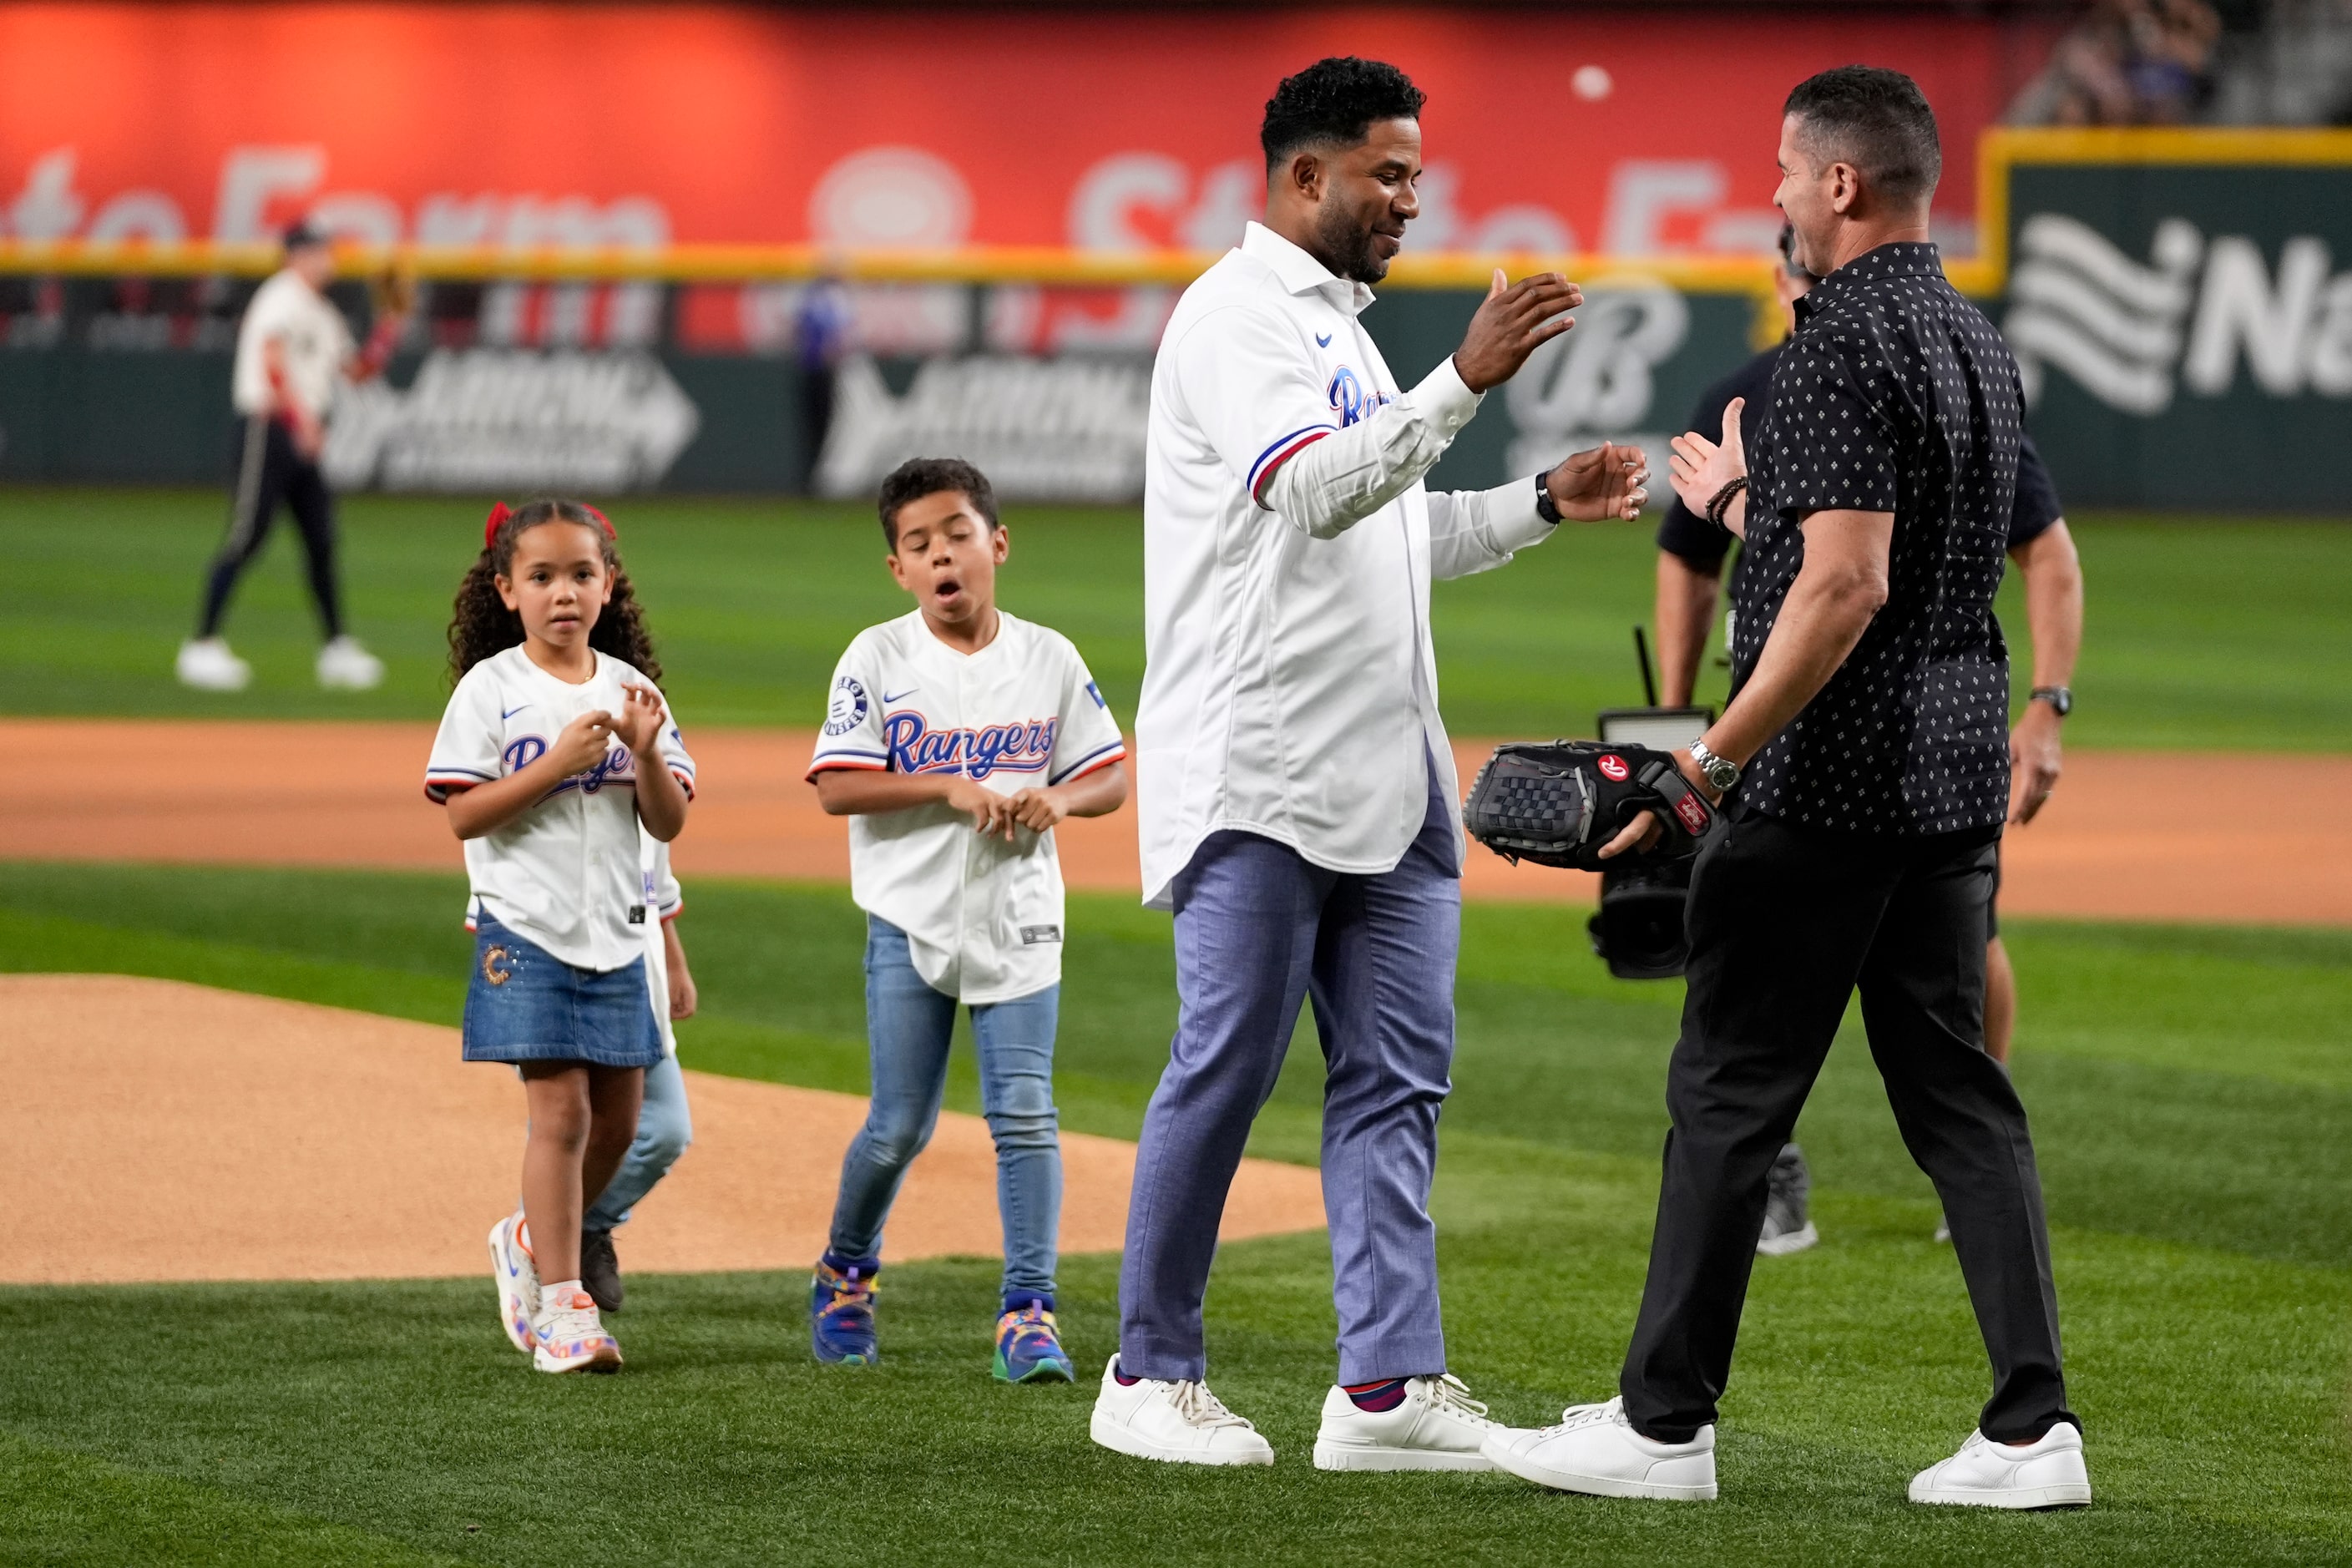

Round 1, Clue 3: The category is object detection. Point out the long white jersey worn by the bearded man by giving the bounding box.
[1136,223,1550,908]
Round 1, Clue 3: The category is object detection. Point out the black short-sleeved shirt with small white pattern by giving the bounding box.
[1731,245,2025,835]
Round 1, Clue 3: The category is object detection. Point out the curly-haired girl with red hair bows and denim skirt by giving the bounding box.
[426,501,694,1373]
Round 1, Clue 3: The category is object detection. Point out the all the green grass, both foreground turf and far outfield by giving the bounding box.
[0,491,2352,1568]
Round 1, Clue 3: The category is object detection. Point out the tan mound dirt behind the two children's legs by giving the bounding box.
[0,975,1324,1300]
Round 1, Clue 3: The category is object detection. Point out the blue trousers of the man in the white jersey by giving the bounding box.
[1120,769,1460,1383]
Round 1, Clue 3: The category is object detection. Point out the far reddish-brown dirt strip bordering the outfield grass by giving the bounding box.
[0,720,2352,926]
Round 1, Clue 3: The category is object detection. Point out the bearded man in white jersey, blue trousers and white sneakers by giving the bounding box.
[1094,58,1646,1469]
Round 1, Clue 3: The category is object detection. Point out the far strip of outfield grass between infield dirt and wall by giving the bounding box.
[0,489,2352,750]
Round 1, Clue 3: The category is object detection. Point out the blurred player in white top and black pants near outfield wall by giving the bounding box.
[179,219,409,691]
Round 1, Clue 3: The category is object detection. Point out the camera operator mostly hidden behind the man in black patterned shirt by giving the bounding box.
[1656,223,2081,1256]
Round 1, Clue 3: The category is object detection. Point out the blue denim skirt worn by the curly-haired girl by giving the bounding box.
[466,910,661,1067]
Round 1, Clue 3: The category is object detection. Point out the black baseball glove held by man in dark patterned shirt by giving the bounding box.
[1463,741,1715,873]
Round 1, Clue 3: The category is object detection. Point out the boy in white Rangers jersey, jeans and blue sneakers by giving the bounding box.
[809,458,1126,1383]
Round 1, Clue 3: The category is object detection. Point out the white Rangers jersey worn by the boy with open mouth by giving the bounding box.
[809,609,1126,1006]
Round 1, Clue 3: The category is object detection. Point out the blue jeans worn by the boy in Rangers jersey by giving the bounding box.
[828,914,1060,1300]
